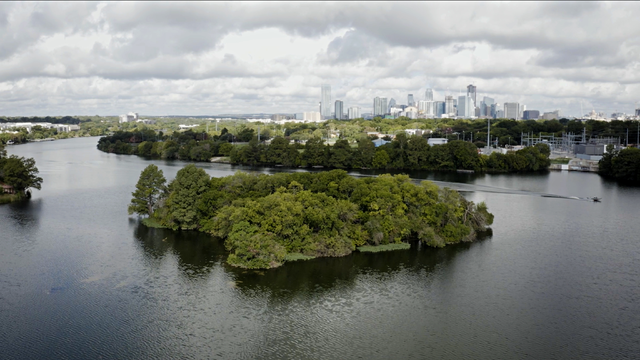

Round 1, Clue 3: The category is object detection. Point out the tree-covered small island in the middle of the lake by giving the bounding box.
[129,164,493,268]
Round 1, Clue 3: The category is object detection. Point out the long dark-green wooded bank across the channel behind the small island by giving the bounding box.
[98,129,550,172]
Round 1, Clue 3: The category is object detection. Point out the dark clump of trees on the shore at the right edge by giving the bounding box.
[598,145,640,185]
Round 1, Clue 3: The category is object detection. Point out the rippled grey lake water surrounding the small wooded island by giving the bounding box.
[0,138,640,359]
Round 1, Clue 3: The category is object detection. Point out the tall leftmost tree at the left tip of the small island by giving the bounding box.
[128,164,167,216]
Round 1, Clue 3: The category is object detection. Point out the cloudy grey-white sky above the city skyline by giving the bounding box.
[0,2,640,116]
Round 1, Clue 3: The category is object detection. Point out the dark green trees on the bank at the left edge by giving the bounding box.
[0,144,42,203]
